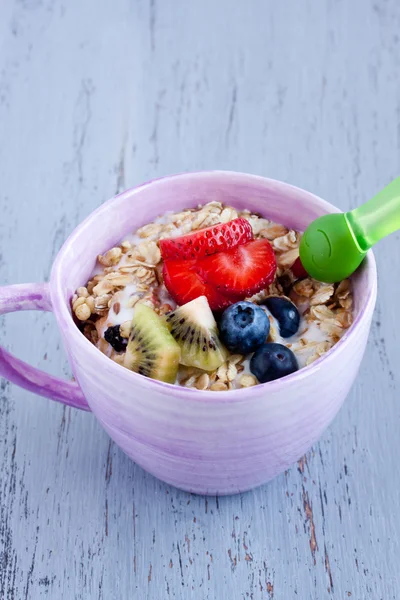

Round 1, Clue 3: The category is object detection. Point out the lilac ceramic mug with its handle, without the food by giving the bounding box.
[0,171,377,495]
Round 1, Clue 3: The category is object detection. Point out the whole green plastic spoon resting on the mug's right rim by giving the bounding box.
[300,177,400,283]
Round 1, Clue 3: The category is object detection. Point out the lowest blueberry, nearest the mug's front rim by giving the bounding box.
[250,344,299,383]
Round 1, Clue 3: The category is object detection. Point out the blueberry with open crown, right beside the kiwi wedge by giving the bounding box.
[219,302,269,354]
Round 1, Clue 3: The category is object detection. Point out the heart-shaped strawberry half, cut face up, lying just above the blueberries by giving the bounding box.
[202,240,276,298]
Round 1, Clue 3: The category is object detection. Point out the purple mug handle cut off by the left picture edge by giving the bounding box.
[0,283,90,411]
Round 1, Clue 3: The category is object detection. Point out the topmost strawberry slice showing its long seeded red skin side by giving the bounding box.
[160,218,253,260]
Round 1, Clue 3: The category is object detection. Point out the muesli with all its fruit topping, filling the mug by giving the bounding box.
[71,202,352,391]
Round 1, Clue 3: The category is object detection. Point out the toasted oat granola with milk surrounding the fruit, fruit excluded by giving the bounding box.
[71,201,353,391]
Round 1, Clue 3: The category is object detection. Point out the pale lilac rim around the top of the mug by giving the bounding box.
[50,170,377,403]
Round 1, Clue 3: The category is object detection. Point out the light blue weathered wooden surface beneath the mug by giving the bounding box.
[0,0,400,600]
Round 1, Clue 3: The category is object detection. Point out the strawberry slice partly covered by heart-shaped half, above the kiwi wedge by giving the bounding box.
[163,260,235,311]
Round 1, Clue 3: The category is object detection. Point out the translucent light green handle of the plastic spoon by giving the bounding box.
[346,177,400,251]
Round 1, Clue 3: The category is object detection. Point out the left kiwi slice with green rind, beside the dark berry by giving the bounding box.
[124,304,181,383]
